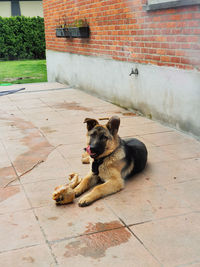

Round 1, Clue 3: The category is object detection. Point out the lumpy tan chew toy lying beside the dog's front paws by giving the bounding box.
[52,173,81,205]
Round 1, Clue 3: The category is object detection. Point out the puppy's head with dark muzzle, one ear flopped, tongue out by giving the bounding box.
[84,116,120,159]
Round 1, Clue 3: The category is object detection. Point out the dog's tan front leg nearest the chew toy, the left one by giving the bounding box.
[74,172,99,197]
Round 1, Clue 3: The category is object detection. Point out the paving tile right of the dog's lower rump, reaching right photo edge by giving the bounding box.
[143,158,200,185]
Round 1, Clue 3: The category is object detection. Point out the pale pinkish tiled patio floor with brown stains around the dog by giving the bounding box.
[0,83,200,267]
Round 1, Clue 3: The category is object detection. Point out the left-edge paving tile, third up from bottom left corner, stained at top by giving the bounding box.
[0,185,30,214]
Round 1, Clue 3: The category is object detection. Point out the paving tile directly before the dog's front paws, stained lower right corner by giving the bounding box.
[35,202,123,241]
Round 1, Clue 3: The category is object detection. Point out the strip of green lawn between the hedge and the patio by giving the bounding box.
[0,60,47,85]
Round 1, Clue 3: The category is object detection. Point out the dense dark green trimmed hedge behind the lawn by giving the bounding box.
[0,16,45,60]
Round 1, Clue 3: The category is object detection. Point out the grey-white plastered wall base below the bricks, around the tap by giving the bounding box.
[46,50,200,138]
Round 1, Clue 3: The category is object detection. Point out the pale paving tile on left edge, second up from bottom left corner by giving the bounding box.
[0,210,44,252]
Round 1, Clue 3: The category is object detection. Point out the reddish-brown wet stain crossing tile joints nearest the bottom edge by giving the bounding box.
[64,221,131,259]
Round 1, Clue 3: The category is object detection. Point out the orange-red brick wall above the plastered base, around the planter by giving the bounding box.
[43,0,200,71]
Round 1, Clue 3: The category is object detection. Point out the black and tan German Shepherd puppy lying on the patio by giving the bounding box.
[74,116,147,207]
